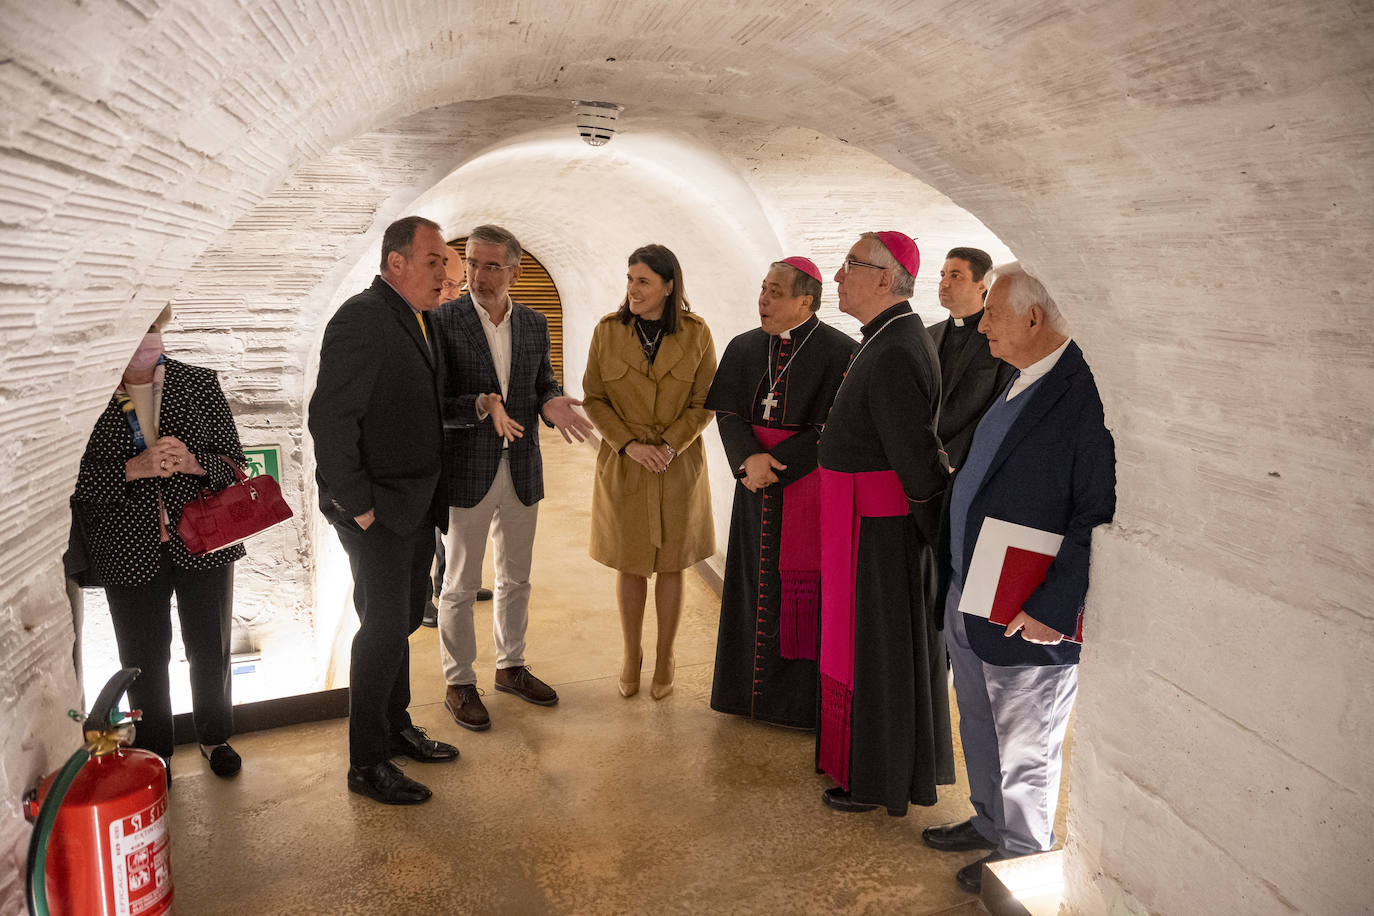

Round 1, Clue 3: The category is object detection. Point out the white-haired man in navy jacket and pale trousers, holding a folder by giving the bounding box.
[922,264,1116,893]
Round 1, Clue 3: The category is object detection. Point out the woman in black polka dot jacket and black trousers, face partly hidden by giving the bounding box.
[76,306,246,777]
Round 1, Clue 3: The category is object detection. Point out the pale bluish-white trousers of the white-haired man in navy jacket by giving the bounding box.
[945,588,1079,856]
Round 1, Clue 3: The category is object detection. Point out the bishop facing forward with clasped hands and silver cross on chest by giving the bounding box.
[706,257,856,728]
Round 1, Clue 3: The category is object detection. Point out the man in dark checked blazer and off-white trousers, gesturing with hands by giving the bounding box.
[434,225,592,732]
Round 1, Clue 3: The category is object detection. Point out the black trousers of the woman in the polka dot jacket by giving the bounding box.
[104,547,234,757]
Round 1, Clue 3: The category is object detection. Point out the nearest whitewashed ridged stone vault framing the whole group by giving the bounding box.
[0,0,1374,913]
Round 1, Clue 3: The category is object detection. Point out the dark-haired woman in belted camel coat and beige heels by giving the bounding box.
[583,244,716,699]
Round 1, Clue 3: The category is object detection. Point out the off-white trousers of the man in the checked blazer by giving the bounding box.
[438,455,539,684]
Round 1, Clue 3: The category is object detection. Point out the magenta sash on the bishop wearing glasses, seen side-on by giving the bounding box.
[816,468,908,790]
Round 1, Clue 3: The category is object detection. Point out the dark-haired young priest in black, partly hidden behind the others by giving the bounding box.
[929,249,1015,468]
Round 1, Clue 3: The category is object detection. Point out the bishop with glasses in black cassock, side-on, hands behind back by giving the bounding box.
[816,232,954,816]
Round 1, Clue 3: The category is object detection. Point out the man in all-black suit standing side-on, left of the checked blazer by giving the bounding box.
[309,217,458,805]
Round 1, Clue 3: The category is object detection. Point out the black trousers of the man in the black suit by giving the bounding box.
[331,519,434,766]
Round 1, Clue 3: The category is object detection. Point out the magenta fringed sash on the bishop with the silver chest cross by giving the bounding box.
[754,426,820,659]
